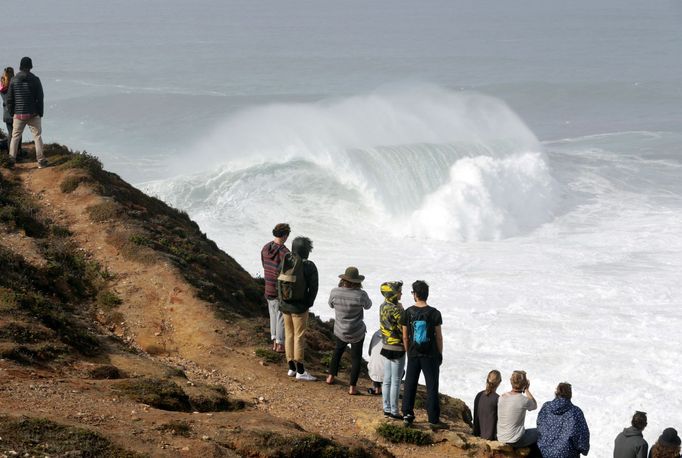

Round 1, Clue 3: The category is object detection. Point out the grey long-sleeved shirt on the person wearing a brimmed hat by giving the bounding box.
[329,287,372,343]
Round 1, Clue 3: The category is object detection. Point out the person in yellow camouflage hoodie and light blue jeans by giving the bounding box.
[379,281,405,420]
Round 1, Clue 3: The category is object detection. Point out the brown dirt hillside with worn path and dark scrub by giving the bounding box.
[0,145,515,457]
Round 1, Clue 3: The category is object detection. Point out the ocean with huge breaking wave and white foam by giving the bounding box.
[0,0,682,457]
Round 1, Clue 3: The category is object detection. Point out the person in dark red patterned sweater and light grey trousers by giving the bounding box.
[260,223,291,353]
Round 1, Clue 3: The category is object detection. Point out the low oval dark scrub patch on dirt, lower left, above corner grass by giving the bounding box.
[114,378,192,412]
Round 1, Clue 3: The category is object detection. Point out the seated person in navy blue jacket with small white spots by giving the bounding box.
[537,383,590,458]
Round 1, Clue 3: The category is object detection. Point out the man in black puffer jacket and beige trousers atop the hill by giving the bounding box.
[6,57,47,168]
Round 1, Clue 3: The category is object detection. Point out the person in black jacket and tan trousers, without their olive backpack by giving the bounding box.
[280,237,318,382]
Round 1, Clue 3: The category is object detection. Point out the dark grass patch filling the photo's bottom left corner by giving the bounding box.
[0,416,145,458]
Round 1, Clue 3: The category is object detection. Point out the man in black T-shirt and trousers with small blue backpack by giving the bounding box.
[400,280,447,430]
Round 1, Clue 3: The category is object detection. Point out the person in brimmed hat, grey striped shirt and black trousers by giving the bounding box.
[327,266,372,394]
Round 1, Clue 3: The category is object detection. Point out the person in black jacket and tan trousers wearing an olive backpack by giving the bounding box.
[277,237,318,382]
